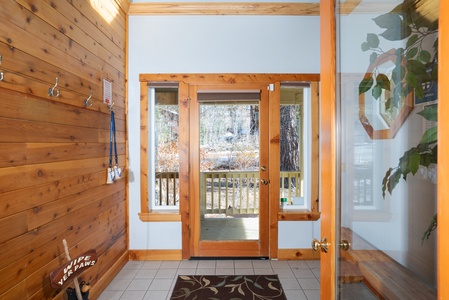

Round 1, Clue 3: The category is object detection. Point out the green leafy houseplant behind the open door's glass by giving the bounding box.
[359,0,438,241]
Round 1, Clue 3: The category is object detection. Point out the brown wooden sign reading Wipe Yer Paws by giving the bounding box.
[50,249,97,289]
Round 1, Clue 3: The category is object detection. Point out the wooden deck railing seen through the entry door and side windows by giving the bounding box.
[155,171,302,215]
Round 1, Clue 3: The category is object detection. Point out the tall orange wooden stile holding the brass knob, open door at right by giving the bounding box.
[320,0,337,300]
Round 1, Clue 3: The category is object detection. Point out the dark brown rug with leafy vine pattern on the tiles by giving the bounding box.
[170,275,287,300]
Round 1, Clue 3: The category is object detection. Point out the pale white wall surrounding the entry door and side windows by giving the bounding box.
[128,16,319,250]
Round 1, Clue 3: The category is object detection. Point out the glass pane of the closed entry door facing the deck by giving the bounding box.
[198,92,260,240]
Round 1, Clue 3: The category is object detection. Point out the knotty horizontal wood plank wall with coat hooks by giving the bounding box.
[0,0,130,299]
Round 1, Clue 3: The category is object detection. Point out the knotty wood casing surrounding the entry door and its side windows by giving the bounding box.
[139,73,320,259]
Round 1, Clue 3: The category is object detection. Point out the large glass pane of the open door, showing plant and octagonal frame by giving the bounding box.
[335,1,438,299]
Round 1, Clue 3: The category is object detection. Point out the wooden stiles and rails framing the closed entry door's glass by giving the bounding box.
[186,82,270,257]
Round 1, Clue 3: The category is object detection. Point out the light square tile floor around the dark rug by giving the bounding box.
[99,260,320,300]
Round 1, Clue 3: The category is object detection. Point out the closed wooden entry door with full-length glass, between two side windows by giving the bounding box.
[191,86,269,256]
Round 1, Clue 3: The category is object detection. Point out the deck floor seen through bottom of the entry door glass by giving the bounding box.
[201,217,259,241]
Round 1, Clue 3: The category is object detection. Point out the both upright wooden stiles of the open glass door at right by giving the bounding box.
[320,0,449,299]
